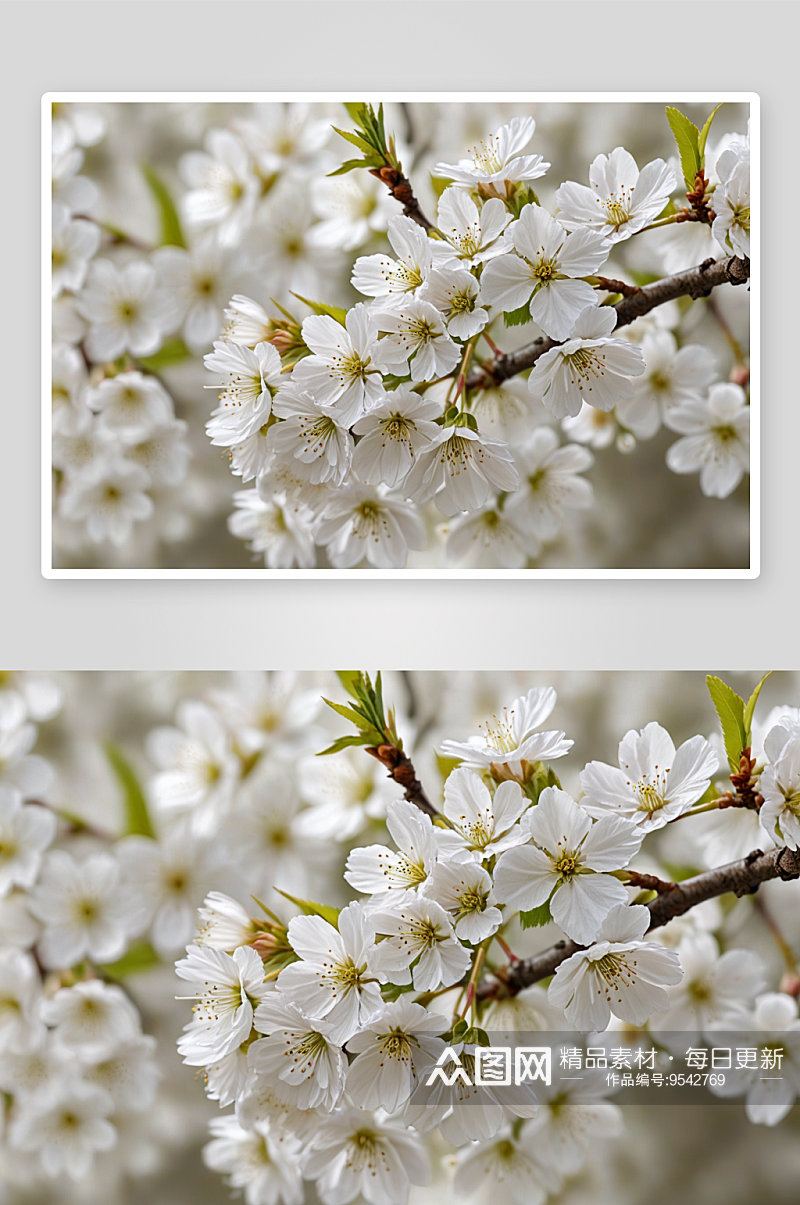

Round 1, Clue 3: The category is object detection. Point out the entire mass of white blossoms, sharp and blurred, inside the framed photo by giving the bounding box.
[53,104,749,569]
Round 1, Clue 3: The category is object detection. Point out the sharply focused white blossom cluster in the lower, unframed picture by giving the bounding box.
[168,680,800,1205]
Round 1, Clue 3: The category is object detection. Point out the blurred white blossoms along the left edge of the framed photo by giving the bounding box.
[52,106,196,558]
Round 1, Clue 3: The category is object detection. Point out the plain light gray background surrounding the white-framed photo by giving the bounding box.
[6,0,800,669]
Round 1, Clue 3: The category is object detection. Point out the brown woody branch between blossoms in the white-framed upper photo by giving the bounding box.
[466,255,749,389]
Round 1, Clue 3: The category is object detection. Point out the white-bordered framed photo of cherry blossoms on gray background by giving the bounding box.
[42,93,759,580]
